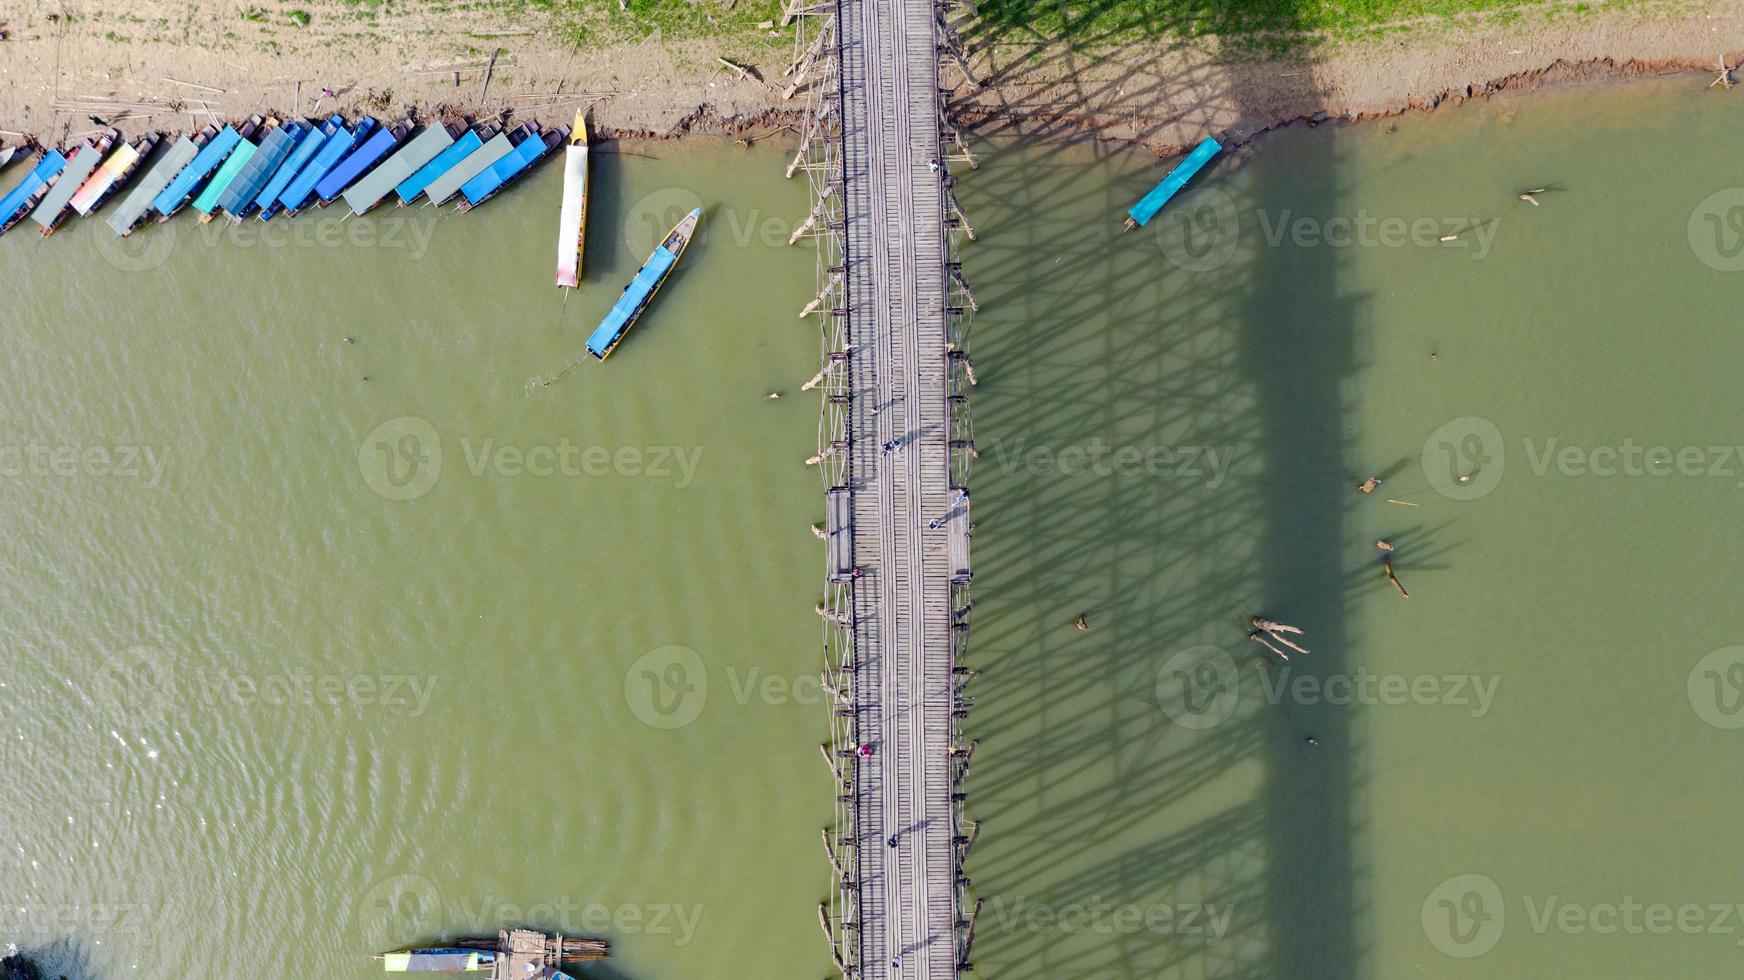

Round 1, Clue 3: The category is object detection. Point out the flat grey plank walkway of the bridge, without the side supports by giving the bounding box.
[837,0,957,980]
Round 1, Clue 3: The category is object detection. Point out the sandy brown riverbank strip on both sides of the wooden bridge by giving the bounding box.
[0,0,1744,153]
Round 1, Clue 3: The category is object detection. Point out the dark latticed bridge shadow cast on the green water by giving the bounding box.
[957,15,1366,980]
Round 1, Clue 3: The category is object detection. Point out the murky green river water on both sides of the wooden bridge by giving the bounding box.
[0,80,1744,980]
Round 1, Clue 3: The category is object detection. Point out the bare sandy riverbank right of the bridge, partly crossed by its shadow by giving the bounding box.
[957,0,1744,153]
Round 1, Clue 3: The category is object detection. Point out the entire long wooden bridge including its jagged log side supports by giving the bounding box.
[788,0,975,980]
